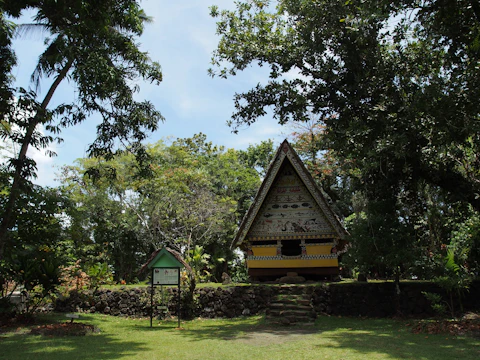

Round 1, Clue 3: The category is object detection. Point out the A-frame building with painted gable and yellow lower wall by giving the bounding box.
[233,140,347,280]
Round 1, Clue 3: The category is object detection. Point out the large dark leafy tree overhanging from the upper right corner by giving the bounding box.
[211,0,480,213]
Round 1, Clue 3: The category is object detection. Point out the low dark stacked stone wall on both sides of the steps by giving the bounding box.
[56,282,480,318]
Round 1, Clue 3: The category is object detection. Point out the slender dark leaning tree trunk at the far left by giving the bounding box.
[0,60,73,260]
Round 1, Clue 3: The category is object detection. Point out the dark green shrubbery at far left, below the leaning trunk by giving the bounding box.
[0,187,72,313]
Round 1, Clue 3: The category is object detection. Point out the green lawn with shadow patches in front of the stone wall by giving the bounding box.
[0,314,480,360]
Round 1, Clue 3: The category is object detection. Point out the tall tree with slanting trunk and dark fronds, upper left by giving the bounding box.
[0,0,163,258]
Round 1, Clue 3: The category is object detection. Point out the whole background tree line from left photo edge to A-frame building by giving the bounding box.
[1,134,273,296]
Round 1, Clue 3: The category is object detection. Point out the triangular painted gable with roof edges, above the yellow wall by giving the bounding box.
[233,140,346,246]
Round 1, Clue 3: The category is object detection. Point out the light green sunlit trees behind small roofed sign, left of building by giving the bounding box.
[62,134,266,282]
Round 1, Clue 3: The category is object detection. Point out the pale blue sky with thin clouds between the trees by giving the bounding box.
[6,0,289,186]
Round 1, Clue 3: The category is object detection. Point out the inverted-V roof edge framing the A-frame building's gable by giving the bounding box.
[232,140,347,247]
